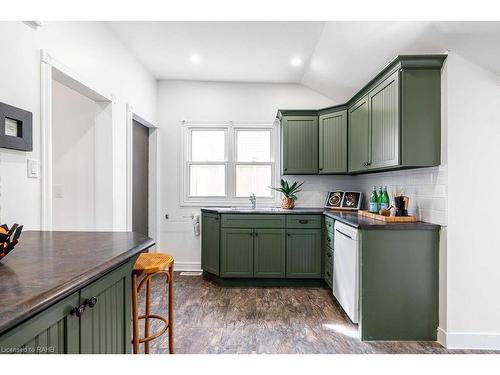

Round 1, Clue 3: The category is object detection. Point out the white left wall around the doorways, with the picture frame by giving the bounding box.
[0,22,156,229]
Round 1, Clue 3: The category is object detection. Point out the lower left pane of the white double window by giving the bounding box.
[189,165,226,197]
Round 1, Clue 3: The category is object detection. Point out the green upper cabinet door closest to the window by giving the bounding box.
[282,116,318,174]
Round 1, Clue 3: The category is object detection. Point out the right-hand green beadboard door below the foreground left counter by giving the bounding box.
[80,262,132,354]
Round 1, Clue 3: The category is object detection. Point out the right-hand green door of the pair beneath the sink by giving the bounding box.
[253,229,286,278]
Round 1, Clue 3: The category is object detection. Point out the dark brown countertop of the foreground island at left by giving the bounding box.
[0,231,154,334]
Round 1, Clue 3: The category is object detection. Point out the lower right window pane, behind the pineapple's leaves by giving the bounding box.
[236,165,271,197]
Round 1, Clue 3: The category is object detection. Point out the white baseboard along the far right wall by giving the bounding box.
[437,328,500,350]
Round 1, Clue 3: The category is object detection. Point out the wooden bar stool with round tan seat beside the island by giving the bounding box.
[132,253,174,354]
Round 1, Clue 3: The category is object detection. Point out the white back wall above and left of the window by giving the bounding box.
[157,81,334,269]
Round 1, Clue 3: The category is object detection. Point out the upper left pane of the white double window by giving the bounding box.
[191,130,225,161]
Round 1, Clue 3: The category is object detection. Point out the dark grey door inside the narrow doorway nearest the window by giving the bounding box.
[132,120,149,236]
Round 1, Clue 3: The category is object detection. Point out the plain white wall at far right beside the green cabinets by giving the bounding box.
[447,53,500,349]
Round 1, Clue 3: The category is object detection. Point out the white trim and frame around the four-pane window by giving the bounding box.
[180,121,280,207]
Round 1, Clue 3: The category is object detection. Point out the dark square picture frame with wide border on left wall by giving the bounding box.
[0,103,33,151]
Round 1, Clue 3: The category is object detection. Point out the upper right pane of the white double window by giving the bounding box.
[236,130,271,162]
